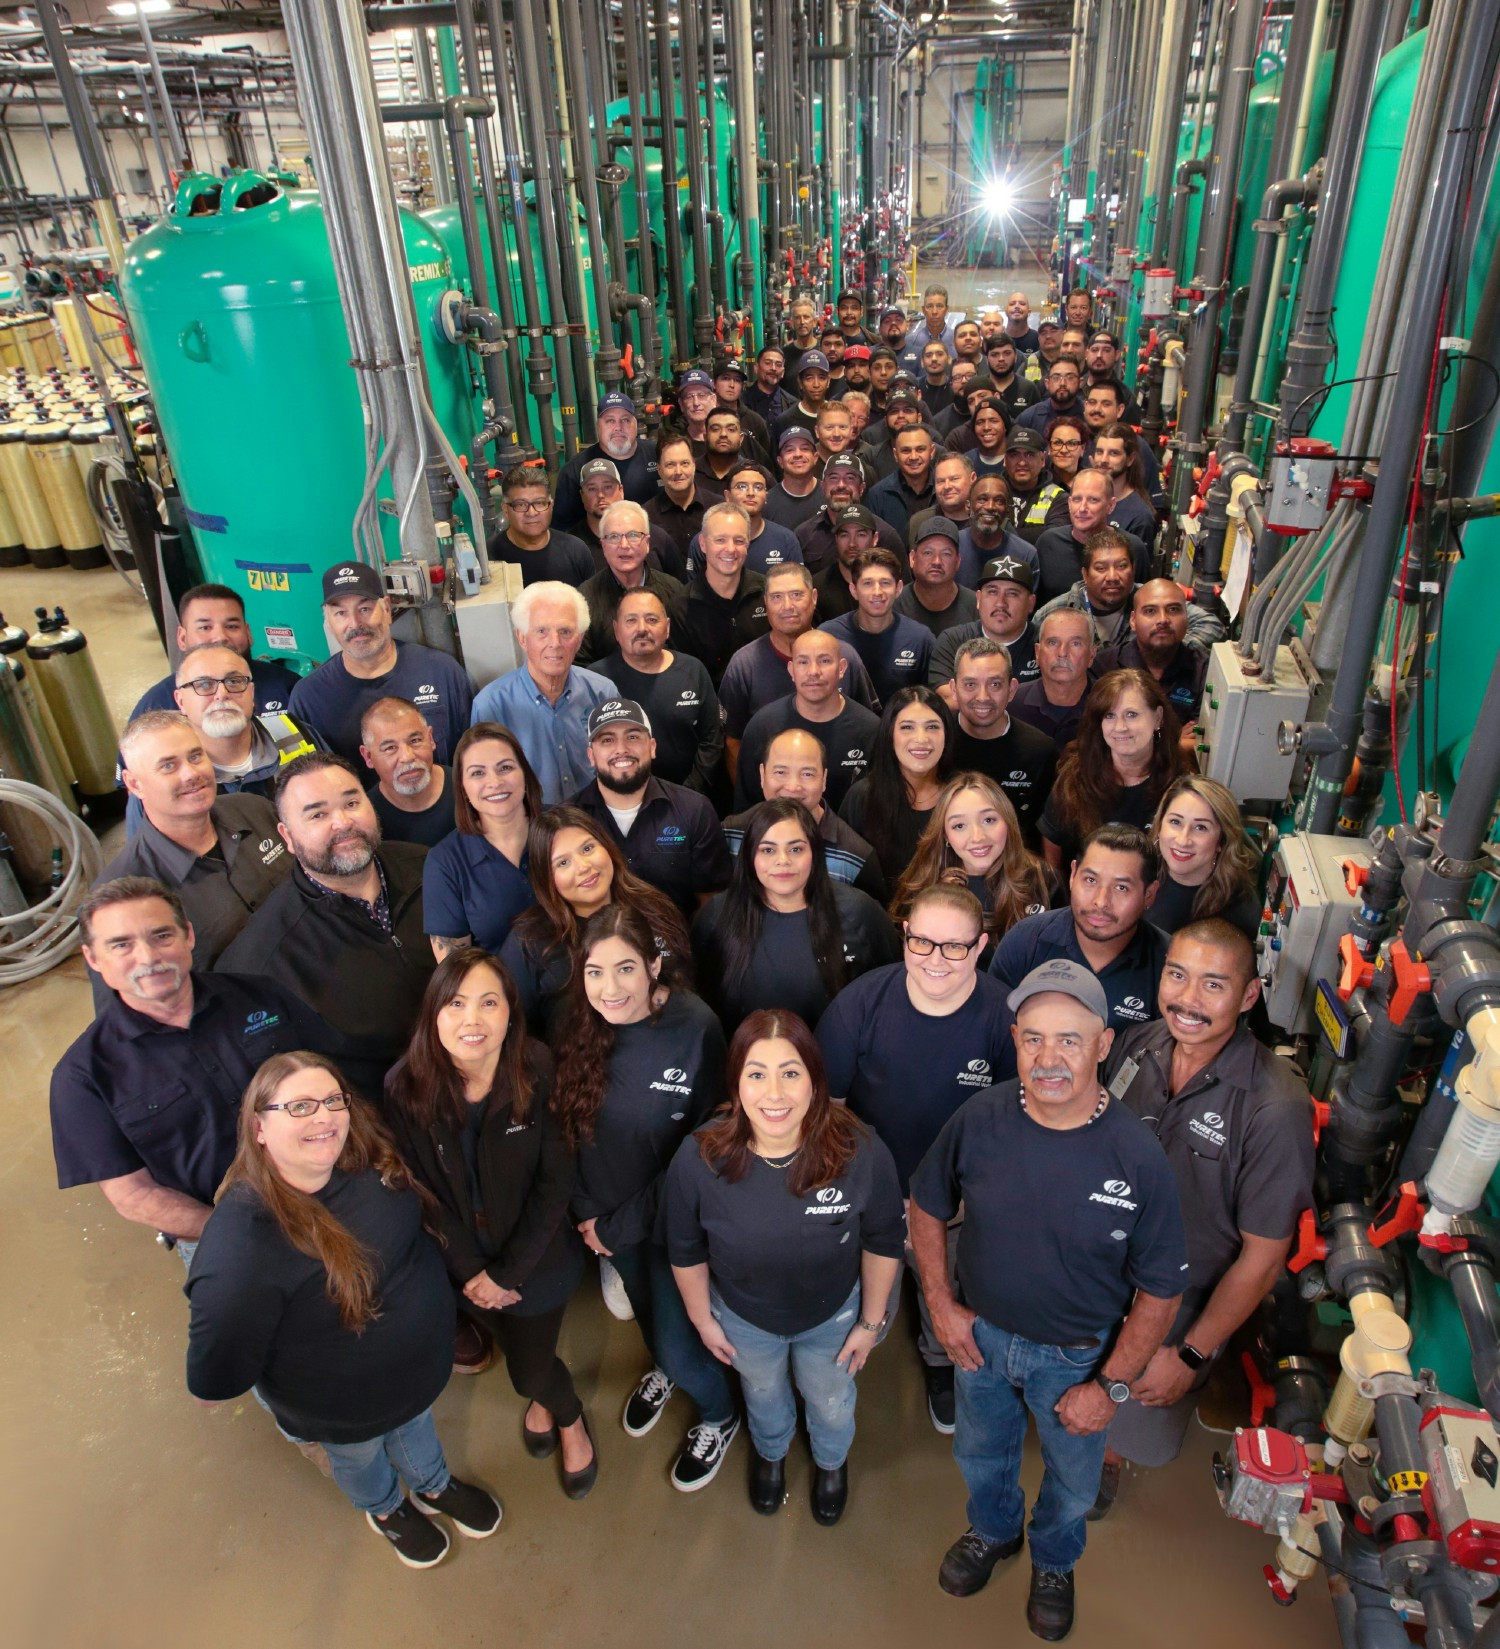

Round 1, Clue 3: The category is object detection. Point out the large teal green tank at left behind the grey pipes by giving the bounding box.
[120,171,478,669]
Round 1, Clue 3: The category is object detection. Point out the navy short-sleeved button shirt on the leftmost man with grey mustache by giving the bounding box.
[51,971,338,1204]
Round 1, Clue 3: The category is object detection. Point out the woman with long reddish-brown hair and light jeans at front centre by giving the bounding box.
[666,1009,905,1524]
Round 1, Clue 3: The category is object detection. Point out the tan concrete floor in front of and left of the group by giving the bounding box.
[0,571,1335,1649]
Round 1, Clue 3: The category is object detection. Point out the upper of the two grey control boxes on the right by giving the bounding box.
[1198,641,1312,801]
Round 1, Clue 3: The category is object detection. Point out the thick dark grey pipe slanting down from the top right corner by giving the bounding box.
[1307,3,1500,833]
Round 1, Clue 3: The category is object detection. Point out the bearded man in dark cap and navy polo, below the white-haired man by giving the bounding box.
[574,699,732,917]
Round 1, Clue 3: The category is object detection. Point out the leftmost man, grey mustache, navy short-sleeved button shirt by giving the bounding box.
[51,876,341,1265]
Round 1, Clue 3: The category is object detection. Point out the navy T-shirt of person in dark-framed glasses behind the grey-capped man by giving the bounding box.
[818,961,1015,1196]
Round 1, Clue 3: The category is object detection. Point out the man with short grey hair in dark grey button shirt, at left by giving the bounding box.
[94,711,292,976]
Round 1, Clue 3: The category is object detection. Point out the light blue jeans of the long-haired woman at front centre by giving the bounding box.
[710,1286,859,1471]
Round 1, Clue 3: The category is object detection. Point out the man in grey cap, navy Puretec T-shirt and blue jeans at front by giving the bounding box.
[908,958,1187,1642]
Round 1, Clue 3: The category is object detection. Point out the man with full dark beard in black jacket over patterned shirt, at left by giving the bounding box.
[218,755,441,1093]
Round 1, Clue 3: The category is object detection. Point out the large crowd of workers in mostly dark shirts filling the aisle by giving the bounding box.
[51,294,1312,1639]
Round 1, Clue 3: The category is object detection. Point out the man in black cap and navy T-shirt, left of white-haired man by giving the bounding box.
[287,561,475,762]
